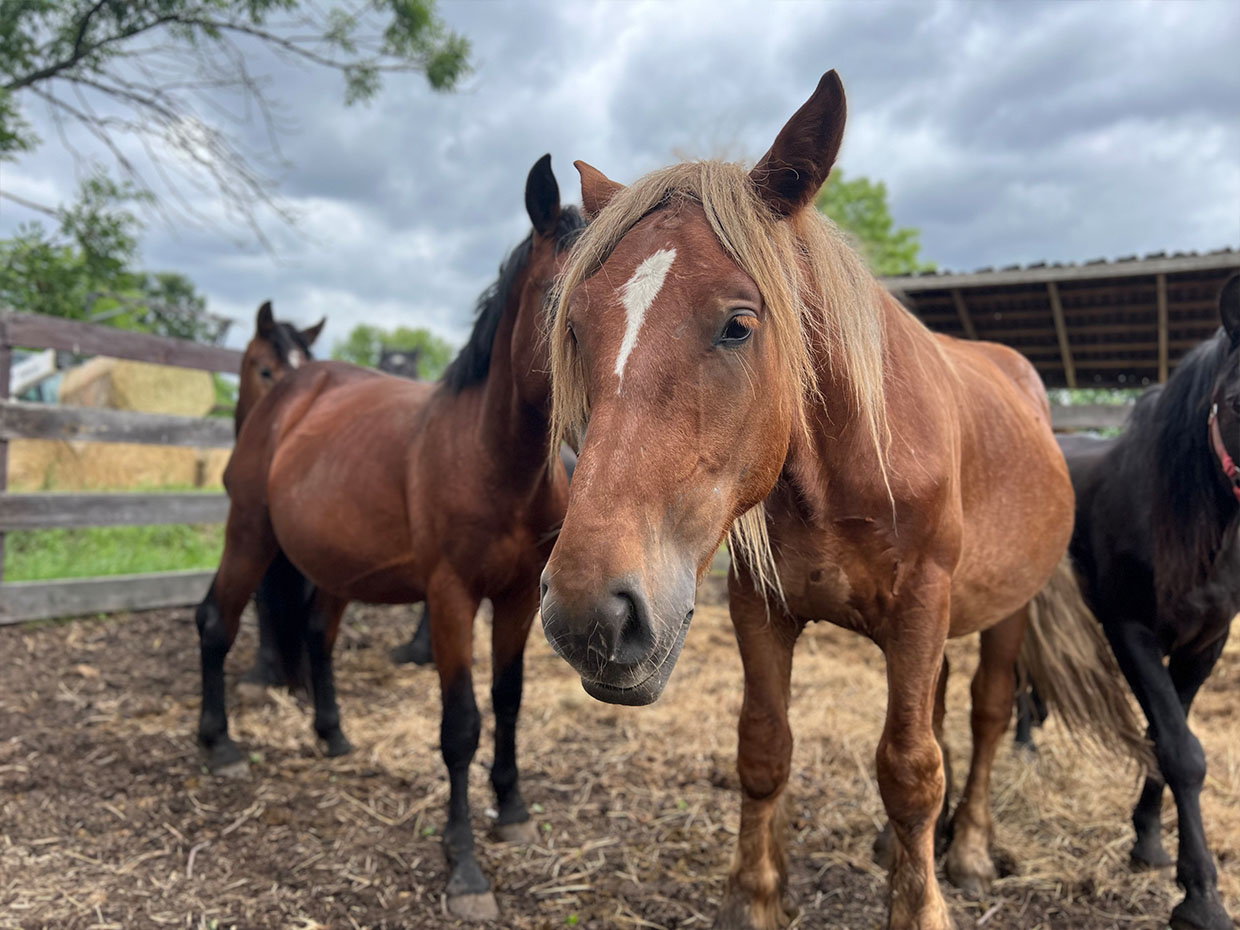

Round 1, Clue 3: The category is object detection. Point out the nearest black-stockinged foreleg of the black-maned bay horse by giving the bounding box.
[427,573,500,920]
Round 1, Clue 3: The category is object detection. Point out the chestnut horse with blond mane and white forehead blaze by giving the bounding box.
[542,72,1141,930]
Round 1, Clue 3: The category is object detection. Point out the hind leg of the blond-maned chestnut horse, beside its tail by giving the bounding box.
[947,609,1027,898]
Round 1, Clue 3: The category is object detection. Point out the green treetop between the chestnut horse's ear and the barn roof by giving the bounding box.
[815,169,934,275]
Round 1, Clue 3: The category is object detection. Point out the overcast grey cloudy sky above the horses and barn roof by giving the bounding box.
[0,0,1240,352]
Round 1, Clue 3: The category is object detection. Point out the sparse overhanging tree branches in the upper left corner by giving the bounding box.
[0,0,469,239]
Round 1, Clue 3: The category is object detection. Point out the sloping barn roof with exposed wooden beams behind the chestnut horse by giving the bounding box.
[883,248,1240,387]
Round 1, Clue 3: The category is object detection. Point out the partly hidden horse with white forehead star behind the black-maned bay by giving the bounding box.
[233,300,327,688]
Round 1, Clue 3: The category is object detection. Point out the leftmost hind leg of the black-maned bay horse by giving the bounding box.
[195,506,277,775]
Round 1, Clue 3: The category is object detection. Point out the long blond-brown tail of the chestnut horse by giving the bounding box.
[1018,554,1153,768]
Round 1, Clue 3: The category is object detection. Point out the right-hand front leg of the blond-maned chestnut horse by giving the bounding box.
[878,572,952,930]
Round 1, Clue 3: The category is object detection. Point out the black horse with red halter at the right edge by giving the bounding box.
[1036,274,1240,930]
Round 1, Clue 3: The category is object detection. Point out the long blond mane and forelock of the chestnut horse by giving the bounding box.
[549,161,889,600]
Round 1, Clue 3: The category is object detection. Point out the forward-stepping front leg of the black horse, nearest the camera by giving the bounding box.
[1104,622,1233,930]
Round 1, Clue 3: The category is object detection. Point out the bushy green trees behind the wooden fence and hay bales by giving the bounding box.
[0,175,228,343]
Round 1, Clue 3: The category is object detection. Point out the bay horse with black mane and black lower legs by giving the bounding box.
[196,156,584,918]
